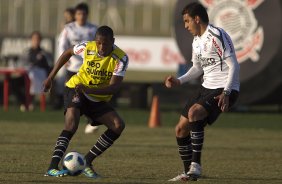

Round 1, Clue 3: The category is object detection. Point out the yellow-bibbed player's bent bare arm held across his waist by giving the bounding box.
[76,75,123,95]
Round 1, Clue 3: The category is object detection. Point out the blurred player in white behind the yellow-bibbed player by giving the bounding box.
[56,3,98,133]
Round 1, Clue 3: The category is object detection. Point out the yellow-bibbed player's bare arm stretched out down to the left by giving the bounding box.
[43,48,73,92]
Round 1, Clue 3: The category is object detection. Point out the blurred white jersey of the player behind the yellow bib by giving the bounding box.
[59,21,98,72]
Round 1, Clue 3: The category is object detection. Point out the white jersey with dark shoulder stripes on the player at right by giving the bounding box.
[192,24,240,91]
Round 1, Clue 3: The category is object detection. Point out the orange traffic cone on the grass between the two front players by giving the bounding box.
[148,95,161,128]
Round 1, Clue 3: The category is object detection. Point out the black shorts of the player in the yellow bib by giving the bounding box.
[64,87,115,125]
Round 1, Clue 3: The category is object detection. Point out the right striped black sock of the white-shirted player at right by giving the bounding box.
[188,120,205,164]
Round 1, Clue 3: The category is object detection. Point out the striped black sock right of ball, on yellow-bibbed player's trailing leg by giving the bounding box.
[85,129,120,165]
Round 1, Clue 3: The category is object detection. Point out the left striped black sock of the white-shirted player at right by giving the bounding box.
[176,135,192,173]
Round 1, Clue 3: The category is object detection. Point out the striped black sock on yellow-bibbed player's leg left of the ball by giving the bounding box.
[48,130,73,170]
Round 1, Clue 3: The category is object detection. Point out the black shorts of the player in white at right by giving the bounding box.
[181,86,239,125]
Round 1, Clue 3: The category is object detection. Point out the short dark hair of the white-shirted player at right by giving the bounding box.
[182,2,209,23]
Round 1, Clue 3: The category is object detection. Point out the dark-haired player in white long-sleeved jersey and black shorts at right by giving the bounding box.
[165,3,240,181]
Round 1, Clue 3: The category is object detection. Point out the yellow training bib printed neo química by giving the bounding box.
[66,41,126,101]
